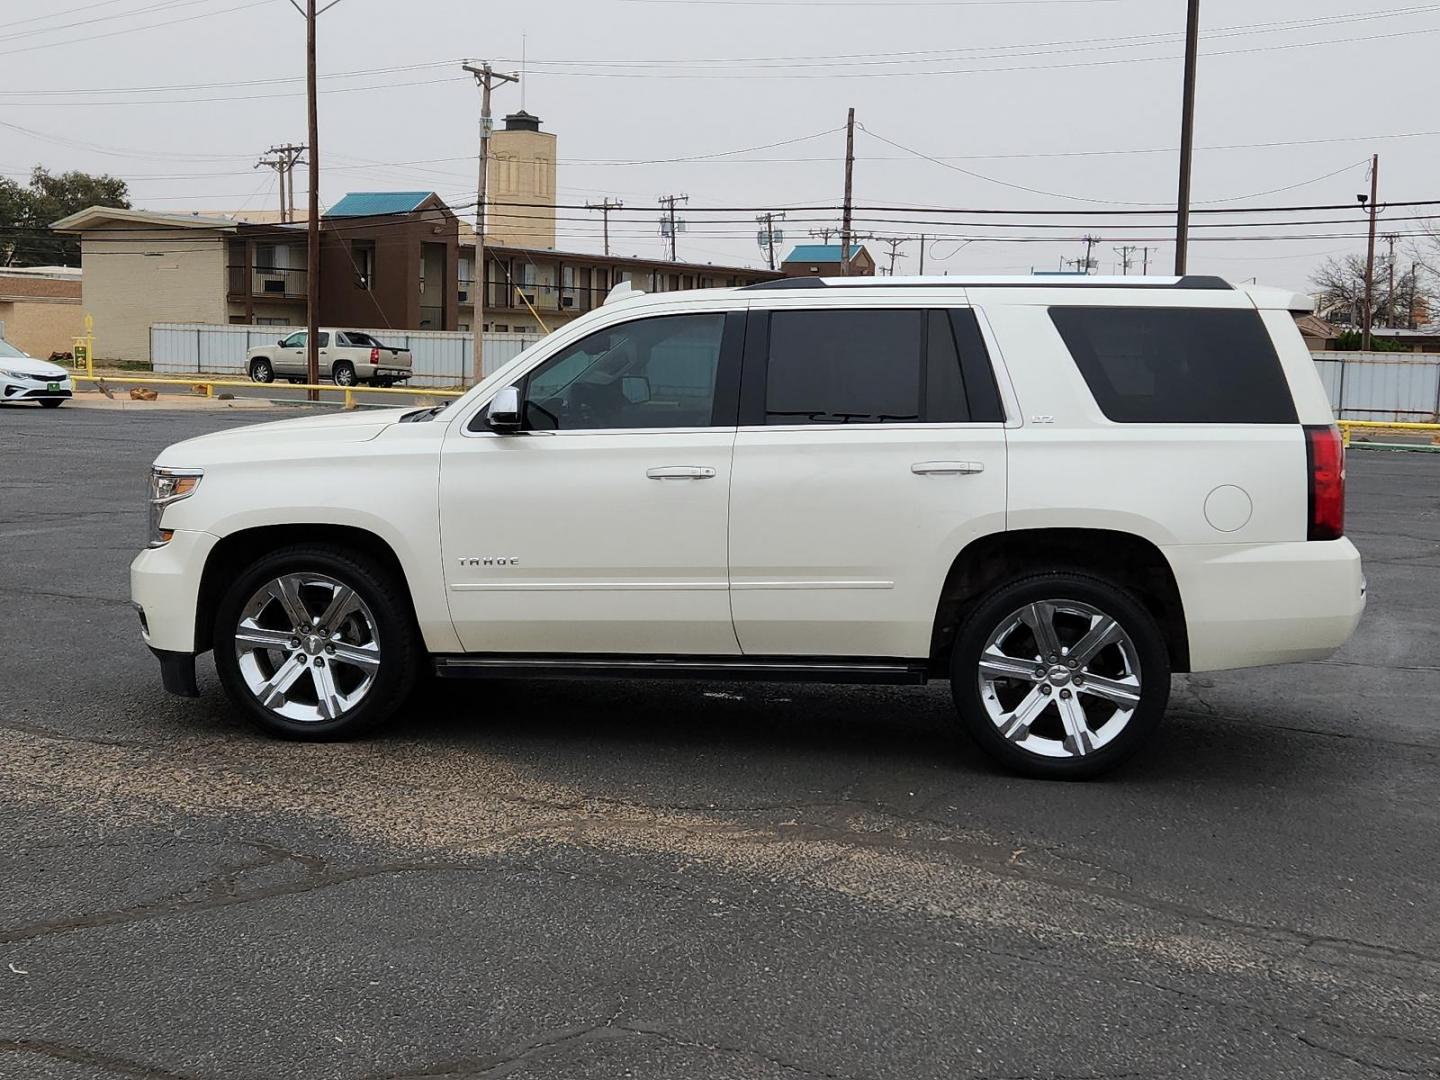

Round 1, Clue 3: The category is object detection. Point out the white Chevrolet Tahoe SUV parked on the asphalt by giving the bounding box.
[131,278,1365,776]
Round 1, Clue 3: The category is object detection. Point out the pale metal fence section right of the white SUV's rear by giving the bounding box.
[1312,353,1440,423]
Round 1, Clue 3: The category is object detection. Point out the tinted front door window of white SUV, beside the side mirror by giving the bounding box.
[521,314,726,431]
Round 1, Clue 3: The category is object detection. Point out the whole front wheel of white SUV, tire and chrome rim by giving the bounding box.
[215,544,425,740]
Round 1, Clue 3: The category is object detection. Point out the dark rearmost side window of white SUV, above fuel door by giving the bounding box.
[1050,308,1296,423]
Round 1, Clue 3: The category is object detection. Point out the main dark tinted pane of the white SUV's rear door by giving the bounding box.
[765,310,922,423]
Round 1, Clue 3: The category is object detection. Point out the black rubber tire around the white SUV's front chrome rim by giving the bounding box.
[215,544,426,742]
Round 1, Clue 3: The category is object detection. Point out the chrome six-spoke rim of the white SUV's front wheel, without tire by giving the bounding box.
[235,573,380,723]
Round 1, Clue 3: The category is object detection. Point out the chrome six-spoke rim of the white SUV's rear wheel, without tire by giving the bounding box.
[979,600,1140,757]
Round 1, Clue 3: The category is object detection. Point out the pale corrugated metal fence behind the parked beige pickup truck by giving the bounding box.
[150,323,540,386]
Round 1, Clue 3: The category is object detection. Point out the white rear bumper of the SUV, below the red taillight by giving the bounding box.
[1162,540,1365,671]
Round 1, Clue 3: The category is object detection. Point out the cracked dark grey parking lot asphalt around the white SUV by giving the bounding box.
[0,408,1440,1080]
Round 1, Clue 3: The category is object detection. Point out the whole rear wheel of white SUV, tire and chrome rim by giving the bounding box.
[950,573,1171,779]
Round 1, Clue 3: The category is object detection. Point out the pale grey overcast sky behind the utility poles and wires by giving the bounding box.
[0,0,1440,288]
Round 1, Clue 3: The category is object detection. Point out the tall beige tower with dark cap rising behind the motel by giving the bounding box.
[485,109,556,248]
